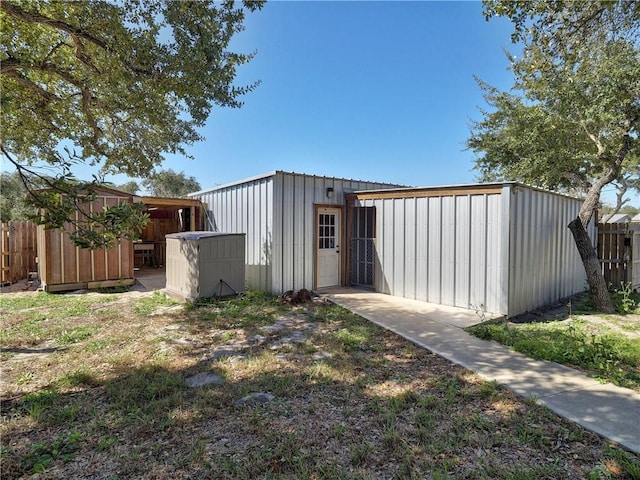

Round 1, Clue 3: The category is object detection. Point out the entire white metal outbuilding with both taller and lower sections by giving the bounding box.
[192,171,595,317]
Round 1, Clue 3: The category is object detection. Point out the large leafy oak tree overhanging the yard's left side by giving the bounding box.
[0,0,262,246]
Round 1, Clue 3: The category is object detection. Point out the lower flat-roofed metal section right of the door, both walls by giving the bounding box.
[356,184,594,316]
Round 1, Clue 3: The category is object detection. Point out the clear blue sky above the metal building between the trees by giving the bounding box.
[5,0,640,205]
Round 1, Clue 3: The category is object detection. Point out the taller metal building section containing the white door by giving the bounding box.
[191,171,398,293]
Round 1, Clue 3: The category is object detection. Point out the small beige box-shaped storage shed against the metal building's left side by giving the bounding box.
[165,232,245,301]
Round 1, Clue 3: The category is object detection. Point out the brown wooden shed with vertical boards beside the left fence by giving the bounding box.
[37,187,135,292]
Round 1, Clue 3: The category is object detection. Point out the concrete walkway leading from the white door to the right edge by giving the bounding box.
[318,288,640,453]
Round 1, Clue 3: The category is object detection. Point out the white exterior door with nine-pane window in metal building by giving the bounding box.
[316,207,342,288]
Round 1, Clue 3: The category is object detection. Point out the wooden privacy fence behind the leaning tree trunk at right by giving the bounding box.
[597,223,640,289]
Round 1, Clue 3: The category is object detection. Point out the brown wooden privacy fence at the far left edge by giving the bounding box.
[0,220,38,285]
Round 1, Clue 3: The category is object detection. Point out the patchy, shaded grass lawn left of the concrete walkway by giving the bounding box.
[0,286,640,480]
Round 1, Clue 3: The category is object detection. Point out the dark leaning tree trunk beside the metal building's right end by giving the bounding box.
[569,217,615,313]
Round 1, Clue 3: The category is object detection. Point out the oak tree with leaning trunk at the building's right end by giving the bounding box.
[467,0,640,312]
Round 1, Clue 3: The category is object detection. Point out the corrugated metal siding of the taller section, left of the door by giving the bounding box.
[193,171,394,293]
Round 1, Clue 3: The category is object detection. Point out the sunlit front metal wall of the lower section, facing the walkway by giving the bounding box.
[357,193,506,313]
